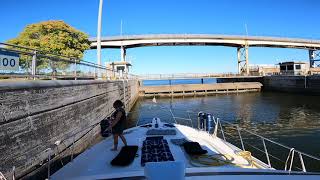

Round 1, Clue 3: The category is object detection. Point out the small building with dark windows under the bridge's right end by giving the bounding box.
[279,61,309,75]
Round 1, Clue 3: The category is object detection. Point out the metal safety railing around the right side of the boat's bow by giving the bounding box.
[132,105,320,173]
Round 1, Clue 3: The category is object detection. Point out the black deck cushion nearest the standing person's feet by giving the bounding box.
[111,146,138,166]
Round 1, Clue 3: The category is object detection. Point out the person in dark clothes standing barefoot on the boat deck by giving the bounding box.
[109,100,127,151]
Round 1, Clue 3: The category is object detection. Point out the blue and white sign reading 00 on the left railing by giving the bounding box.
[0,50,19,71]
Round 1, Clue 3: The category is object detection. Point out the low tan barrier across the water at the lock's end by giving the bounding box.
[139,82,262,97]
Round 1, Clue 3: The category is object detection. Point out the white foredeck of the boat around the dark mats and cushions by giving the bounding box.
[51,119,318,180]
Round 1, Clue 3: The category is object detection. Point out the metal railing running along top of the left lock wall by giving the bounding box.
[0,43,137,80]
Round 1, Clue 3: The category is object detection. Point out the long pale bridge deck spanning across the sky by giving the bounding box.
[90,34,320,50]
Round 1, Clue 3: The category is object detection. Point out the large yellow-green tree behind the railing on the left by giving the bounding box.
[7,20,90,69]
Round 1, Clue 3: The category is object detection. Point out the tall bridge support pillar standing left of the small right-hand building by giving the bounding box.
[237,45,249,75]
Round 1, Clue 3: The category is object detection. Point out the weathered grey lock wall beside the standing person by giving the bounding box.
[0,80,139,177]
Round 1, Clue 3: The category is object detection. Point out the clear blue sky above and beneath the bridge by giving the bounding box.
[0,0,320,74]
